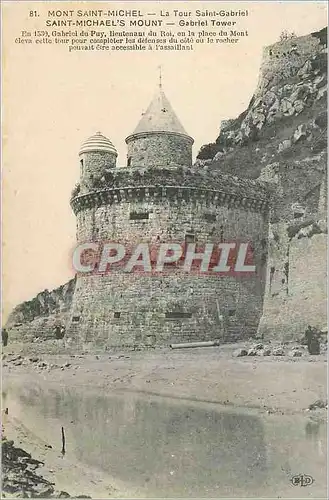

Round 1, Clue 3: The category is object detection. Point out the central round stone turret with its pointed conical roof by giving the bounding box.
[126,84,194,168]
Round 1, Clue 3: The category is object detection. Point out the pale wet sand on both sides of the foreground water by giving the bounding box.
[3,345,327,498]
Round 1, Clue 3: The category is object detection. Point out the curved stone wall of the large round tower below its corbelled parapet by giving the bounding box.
[68,191,268,347]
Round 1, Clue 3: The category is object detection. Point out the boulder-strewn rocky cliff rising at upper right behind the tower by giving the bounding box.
[197,29,327,170]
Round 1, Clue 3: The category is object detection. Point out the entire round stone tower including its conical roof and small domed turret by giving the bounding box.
[67,87,268,349]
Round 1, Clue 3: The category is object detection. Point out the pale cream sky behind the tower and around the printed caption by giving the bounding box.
[2,1,327,321]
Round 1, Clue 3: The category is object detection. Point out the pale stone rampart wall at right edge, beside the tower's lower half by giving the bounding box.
[259,223,327,341]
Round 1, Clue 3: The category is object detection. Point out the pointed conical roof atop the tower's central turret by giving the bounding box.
[131,86,188,136]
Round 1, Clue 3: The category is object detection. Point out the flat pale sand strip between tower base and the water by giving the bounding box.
[3,344,327,412]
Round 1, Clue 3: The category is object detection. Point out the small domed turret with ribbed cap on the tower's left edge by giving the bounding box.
[79,132,118,189]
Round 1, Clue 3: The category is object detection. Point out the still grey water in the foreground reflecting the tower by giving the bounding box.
[3,387,325,498]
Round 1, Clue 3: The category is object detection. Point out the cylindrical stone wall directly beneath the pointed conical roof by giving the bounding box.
[126,132,193,168]
